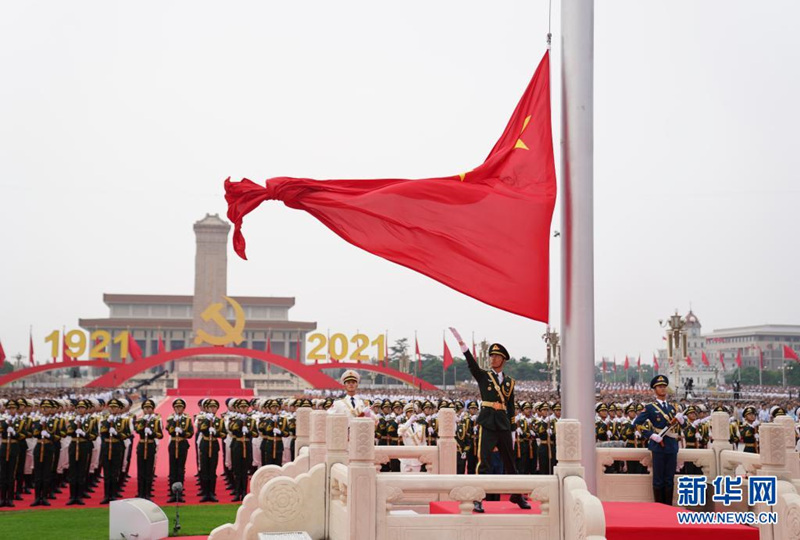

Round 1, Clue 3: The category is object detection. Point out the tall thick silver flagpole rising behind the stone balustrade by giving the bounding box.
[561,0,597,493]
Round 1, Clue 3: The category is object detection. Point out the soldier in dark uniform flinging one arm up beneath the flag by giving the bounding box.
[450,328,530,513]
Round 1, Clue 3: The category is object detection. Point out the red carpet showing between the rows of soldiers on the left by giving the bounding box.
[0,394,238,513]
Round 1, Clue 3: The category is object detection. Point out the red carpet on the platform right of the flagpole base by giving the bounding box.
[603,502,758,540]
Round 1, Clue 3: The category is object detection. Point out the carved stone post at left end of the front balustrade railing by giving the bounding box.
[347,418,377,540]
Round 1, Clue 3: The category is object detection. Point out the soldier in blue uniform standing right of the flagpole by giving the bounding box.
[633,375,686,506]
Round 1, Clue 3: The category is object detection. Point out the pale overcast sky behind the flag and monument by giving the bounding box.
[0,0,800,368]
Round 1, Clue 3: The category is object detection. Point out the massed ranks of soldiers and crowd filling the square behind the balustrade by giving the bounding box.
[0,378,800,506]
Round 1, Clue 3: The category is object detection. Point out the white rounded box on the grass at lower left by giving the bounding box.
[108,499,169,540]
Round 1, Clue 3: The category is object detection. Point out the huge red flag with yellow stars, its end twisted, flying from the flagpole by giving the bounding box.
[225,53,556,322]
